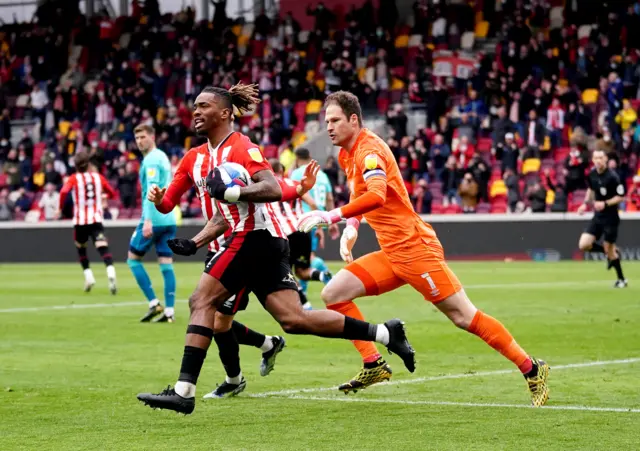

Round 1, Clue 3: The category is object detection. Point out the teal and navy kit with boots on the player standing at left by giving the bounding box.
[127,149,176,322]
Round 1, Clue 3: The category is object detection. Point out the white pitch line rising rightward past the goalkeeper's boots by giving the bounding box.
[251,357,640,398]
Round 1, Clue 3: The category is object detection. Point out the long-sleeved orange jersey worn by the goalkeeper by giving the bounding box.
[338,128,443,262]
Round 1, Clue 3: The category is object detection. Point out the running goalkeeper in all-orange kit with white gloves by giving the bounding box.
[298,91,549,407]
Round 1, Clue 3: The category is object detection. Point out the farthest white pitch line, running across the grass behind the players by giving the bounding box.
[0,280,610,313]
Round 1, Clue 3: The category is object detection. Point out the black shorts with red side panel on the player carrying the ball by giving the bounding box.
[204,230,298,314]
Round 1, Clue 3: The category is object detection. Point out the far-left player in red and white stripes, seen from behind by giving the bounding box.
[59,152,117,294]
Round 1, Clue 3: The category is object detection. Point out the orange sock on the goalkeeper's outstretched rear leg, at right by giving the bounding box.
[467,310,533,374]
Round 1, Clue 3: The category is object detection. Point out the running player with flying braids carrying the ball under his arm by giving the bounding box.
[138,84,413,414]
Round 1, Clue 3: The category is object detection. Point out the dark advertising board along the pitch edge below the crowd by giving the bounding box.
[0,213,640,263]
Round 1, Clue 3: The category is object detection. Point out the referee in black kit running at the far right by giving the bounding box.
[578,150,627,288]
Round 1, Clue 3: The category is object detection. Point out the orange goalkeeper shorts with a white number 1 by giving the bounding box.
[345,251,462,303]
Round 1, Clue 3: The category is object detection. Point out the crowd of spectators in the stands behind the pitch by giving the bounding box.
[0,0,640,220]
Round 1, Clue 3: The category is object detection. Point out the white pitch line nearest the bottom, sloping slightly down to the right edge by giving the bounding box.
[268,395,640,413]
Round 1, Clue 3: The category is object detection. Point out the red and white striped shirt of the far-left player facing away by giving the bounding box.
[59,171,116,225]
